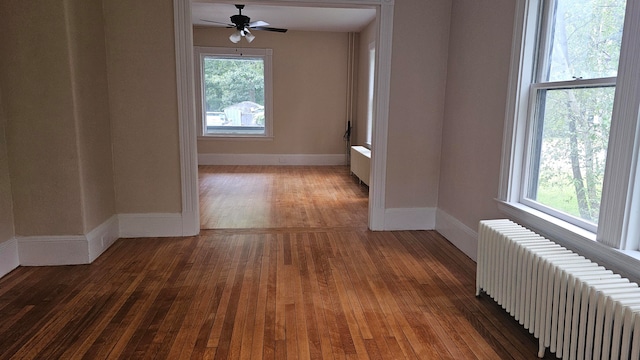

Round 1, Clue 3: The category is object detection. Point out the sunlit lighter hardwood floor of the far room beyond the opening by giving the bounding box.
[199,166,368,229]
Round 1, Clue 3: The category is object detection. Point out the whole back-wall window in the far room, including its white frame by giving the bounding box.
[195,47,271,137]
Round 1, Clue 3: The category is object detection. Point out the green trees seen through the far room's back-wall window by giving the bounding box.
[203,56,264,112]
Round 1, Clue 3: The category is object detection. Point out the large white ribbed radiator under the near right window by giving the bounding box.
[476,220,640,360]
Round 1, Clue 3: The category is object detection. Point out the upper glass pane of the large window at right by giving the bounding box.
[542,0,626,81]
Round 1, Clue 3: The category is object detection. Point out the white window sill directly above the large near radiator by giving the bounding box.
[497,200,640,283]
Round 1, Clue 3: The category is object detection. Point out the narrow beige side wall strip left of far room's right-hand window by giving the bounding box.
[351,20,378,145]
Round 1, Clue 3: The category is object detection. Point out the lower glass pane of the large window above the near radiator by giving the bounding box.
[525,87,615,224]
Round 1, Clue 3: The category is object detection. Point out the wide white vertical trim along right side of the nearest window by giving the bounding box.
[597,1,640,250]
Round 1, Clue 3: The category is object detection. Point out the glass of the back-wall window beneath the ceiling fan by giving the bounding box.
[203,56,265,135]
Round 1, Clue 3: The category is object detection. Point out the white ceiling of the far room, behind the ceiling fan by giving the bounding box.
[191,1,376,32]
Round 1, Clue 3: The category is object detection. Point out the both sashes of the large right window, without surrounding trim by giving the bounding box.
[520,0,625,232]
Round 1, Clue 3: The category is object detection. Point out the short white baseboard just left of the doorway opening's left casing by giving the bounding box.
[118,213,185,238]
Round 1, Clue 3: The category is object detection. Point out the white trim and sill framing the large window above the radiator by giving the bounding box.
[497,0,640,272]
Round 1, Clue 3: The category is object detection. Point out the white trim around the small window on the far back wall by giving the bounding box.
[193,46,273,140]
